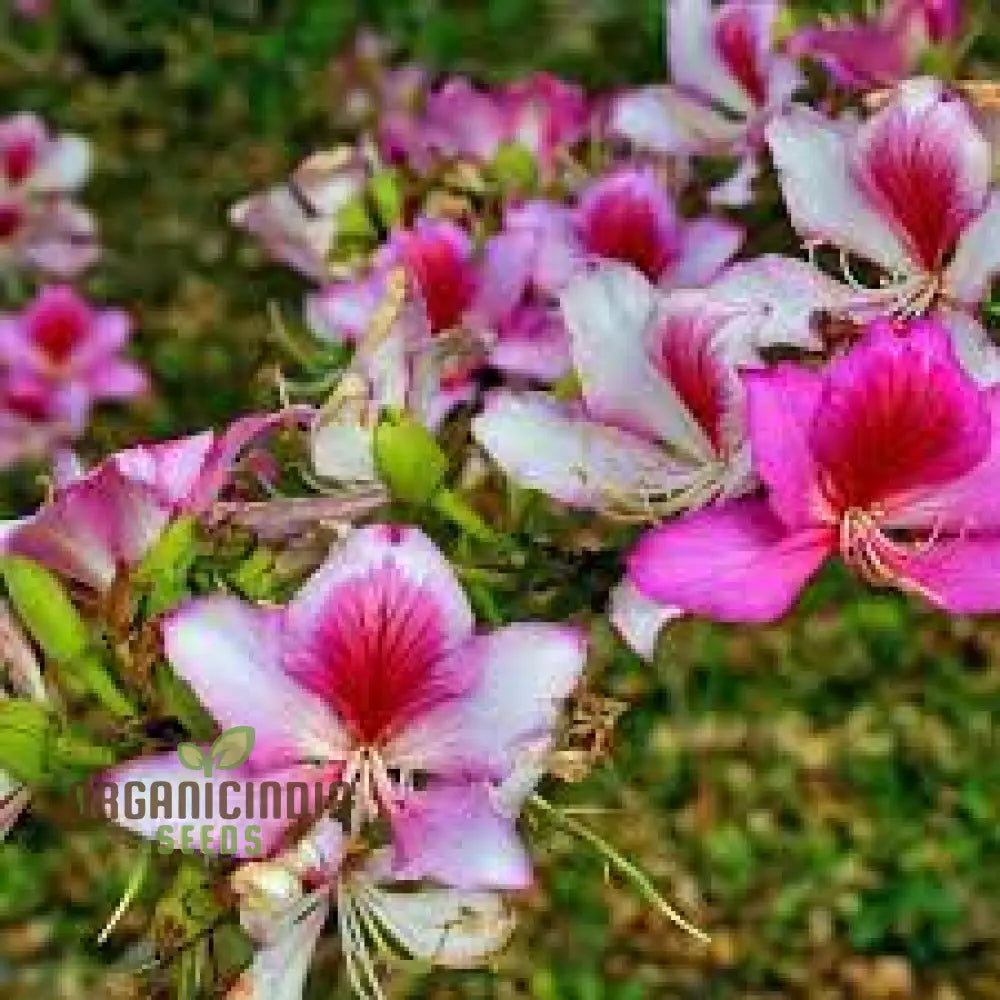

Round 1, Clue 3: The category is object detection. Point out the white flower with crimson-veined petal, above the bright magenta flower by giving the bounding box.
[768,79,1000,378]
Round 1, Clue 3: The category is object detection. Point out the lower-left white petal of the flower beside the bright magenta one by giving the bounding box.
[472,392,698,510]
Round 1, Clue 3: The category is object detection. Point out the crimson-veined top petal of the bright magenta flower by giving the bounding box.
[811,321,991,513]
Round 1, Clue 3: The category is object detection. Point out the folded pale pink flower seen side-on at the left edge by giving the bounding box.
[2,412,308,590]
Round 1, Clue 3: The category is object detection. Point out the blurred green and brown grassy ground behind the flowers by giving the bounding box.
[0,0,1000,1000]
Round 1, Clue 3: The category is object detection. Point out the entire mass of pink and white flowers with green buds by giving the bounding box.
[0,0,1000,1000]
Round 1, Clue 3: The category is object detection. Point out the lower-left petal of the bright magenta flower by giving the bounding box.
[628,499,835,622]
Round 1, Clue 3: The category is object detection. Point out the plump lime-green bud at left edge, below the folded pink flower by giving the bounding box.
[0,556,89,660]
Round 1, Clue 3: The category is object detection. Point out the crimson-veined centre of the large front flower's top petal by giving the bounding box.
[286,563,462,746]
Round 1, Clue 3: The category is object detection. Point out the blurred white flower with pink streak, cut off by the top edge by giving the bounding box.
[610,0,801,205]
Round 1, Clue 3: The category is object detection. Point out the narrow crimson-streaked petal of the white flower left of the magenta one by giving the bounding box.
[653,315,730,454]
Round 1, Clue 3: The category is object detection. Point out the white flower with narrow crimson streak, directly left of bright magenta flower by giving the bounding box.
[473,265,747,518]
